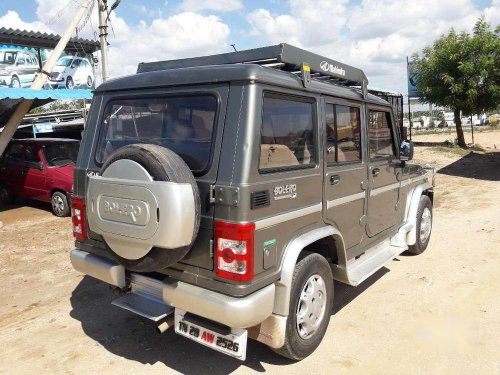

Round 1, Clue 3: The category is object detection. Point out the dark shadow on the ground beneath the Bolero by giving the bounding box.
[70,267,389,374]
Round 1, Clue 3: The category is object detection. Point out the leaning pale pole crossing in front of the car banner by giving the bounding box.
[0,0,94,156]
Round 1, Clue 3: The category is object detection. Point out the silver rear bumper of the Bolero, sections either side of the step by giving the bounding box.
[70,249,275,328]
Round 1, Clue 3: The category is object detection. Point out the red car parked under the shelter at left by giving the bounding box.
[0,138,80,216]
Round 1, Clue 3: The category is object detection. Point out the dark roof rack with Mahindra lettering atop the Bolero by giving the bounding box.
[137,43,368,97]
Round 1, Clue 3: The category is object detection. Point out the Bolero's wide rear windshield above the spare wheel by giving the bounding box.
[96,95,217,173]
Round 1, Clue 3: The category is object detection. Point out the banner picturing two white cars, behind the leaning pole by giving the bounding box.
[0,45,96,90]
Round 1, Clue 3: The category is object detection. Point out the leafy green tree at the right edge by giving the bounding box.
[414,18,500,147]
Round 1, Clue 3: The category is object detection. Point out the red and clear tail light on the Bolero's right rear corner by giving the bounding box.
[215,221,255,281]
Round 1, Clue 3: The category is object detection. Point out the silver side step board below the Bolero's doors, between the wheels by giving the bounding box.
[332,239,408,286]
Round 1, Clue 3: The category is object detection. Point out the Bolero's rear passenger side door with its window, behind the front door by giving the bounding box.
[323,98,367,248]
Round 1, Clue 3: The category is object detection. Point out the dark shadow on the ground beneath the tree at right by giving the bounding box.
[438,152,500,181]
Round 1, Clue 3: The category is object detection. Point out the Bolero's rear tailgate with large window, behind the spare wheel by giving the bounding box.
[89,84,229,270]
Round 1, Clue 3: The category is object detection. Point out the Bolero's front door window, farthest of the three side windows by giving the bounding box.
[368,111,396,159]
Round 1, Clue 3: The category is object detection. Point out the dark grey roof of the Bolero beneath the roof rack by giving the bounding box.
[94,64,388,105]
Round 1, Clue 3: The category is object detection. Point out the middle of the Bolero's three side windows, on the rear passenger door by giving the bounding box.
[326,104,361,163]
